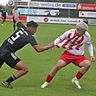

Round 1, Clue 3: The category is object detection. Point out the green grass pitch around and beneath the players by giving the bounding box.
[0,22,96,96]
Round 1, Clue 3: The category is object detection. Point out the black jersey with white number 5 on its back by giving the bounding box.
[2,22,37,52]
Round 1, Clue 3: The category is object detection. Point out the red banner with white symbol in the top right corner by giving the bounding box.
[77,4,96,10]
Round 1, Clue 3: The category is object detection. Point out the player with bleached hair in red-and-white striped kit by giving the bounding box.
[41,22,95,89]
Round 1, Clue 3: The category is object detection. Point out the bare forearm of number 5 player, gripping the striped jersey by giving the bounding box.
[33,42,54,52]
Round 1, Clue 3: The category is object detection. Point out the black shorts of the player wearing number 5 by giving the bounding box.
[0,48,20,68]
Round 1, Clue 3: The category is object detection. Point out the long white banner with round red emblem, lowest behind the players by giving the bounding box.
[27,16,83,24]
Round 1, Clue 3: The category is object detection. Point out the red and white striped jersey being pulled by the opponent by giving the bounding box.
[54,29,92,55]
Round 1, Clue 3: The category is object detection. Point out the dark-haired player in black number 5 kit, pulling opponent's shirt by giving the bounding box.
[0,6,53,88]
